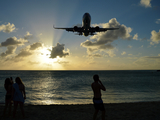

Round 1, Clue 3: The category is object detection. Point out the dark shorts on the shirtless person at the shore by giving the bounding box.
[93,98,105,111]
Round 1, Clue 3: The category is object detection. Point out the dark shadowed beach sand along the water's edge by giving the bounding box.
[0,102,160,120]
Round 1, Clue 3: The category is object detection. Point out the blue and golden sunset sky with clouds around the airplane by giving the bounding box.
[0,0,160,70]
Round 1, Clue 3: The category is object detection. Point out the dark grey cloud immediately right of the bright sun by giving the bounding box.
[50,43,69,58]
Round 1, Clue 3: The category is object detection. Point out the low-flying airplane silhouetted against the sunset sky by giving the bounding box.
[53,13,119,37]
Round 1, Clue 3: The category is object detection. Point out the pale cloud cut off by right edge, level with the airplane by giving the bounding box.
[150,30,160,45]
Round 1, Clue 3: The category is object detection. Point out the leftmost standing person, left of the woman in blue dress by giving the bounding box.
[3,78,13,116]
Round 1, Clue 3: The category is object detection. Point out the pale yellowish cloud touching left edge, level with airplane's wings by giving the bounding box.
[0,23,16,33]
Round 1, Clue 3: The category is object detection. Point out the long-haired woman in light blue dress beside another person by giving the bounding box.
[13,77,26,118]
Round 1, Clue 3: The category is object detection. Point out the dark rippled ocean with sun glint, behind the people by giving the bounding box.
[0,70,160,105]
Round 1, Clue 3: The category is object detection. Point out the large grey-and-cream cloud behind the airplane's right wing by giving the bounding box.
[81,18,132,47]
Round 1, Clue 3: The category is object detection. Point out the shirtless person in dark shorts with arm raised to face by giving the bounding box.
[91,75,106,120]
